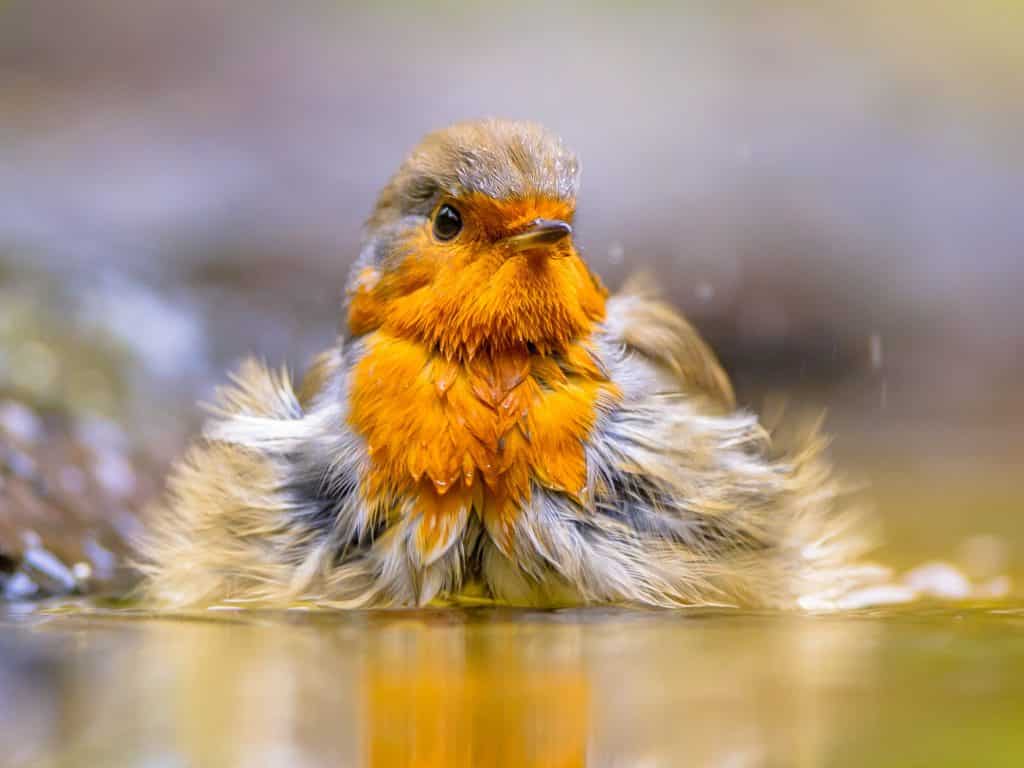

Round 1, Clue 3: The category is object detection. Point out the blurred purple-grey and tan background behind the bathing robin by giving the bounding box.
[0,0,1024,567]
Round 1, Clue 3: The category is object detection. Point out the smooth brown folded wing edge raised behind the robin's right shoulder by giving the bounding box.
[605,280,735,411]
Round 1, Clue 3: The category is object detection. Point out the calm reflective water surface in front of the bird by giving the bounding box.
[0,602,1024,768]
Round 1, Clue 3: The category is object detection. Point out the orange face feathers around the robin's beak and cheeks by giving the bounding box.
[348,196,606,359]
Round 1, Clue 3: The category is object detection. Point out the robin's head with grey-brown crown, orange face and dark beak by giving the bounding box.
[348,120,606,358]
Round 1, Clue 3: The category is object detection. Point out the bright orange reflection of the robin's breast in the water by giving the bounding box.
[364,626,590,768]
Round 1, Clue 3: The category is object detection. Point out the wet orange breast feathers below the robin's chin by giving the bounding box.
[349,332,617,562]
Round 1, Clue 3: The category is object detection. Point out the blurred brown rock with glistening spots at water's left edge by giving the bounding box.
[0,398,156,599]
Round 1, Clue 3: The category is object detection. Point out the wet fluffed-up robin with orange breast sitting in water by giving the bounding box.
[136,119,877,609]
